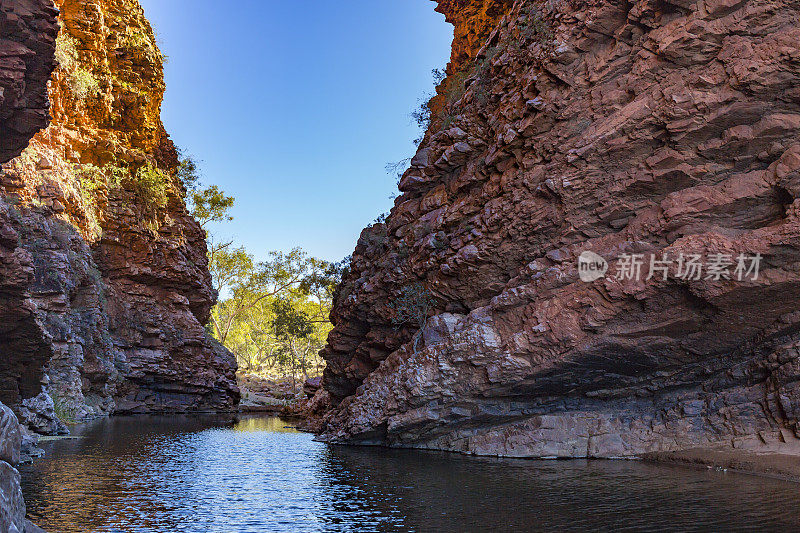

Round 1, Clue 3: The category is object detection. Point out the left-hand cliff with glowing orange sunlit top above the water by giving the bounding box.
[0,0,239,432]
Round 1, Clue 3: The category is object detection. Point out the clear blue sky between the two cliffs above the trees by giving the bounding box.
[140,0,452,260]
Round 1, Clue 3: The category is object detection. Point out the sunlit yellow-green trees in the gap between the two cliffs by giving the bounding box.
[178,150,345,386]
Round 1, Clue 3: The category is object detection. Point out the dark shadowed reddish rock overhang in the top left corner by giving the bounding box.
[0,0,58,163]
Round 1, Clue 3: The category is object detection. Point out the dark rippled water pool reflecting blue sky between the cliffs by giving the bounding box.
[17,417,800,533]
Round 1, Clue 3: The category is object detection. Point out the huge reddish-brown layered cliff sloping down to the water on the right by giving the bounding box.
[312,0,800,457]
